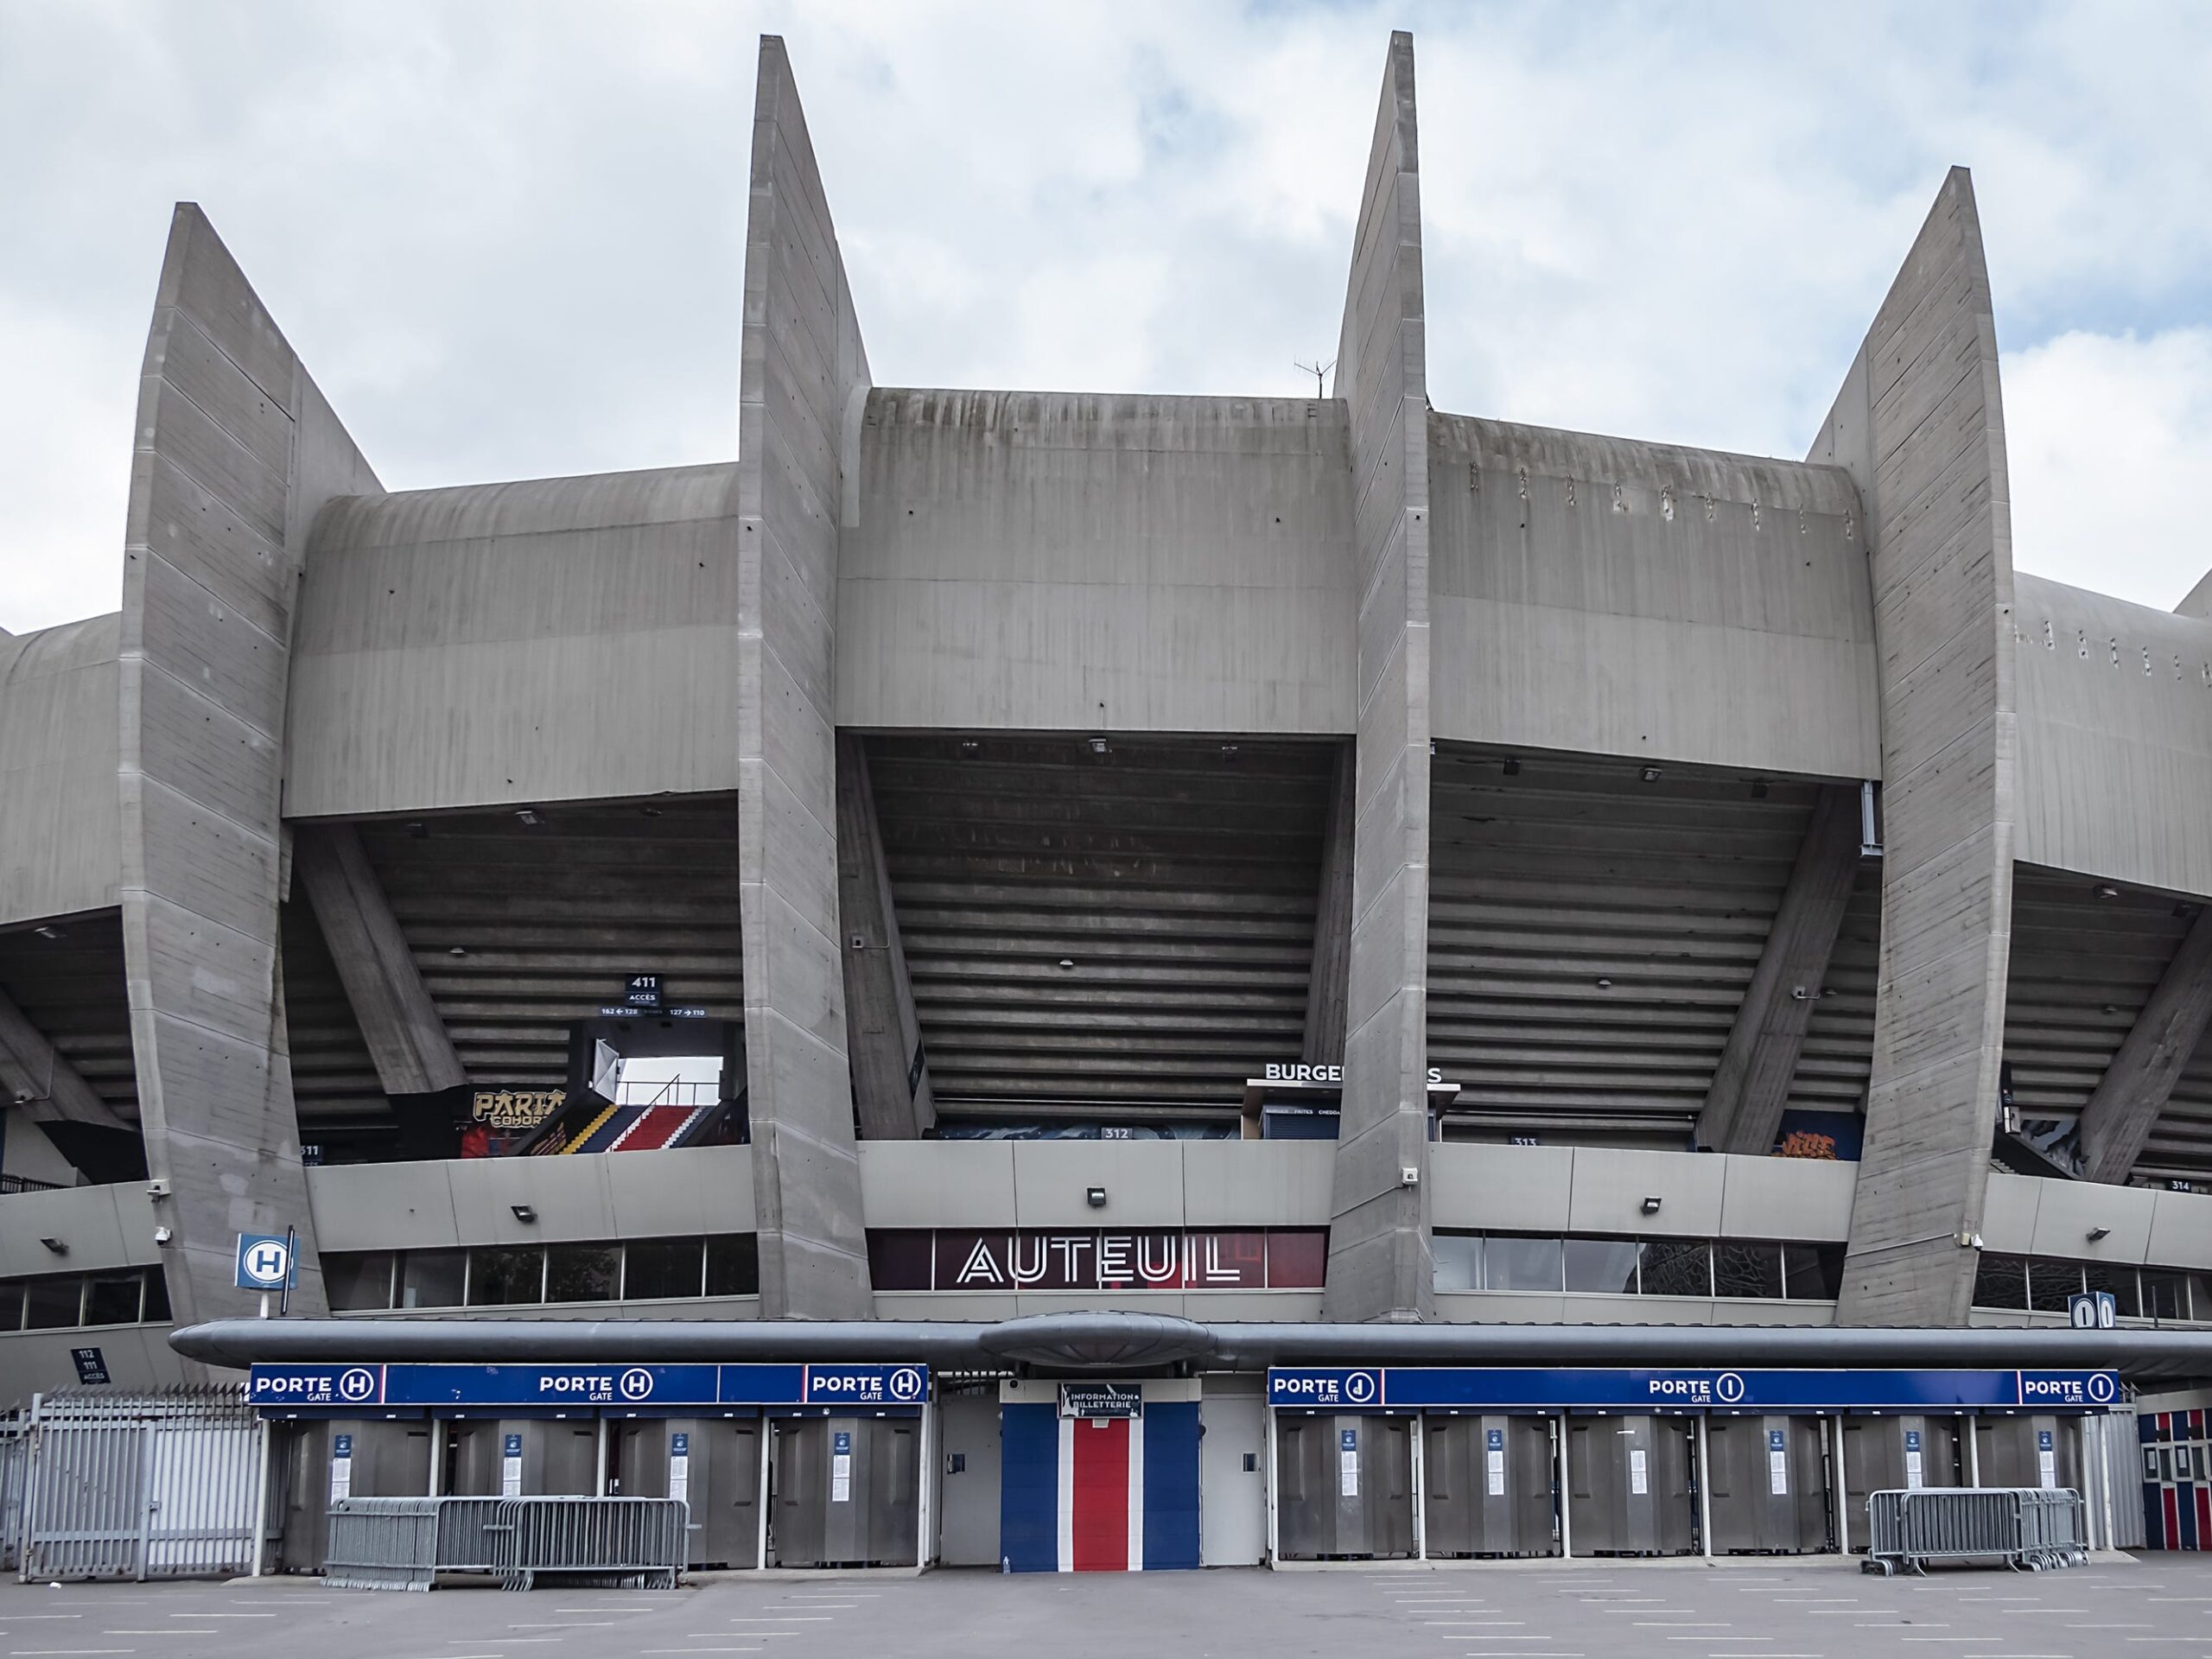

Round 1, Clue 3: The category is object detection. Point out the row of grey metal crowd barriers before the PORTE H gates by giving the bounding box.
[323,1497,690,1591]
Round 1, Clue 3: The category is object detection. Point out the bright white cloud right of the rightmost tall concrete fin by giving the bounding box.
[2004,327,2212,611]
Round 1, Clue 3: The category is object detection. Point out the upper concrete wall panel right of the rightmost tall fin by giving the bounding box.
[2013,575,2212,911]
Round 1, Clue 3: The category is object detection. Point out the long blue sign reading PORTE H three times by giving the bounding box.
[245,1365,929,1407]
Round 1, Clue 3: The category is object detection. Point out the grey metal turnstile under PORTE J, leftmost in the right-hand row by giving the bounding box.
[1274,1411,1414,1561]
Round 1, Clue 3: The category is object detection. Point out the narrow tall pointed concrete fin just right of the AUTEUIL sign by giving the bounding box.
[1323,33,1435,1320]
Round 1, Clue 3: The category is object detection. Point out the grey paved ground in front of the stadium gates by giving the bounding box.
[0,1555,2212,1659]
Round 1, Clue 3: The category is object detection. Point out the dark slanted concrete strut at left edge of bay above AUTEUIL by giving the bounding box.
[836,732,938,1141]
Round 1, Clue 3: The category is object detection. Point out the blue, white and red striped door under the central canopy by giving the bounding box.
[1000,1400,1199,1573]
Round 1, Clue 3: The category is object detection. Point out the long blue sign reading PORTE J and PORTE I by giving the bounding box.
[1268,1365,2121,1411]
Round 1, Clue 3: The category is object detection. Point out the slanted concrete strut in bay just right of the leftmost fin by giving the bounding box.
[292,823,469,1095]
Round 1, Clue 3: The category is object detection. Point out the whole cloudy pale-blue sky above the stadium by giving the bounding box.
[0,0,2212,631]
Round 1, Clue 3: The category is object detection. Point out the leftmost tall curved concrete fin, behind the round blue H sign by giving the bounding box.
[118,204,378,1323]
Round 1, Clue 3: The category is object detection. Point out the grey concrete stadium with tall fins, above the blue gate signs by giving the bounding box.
[0,35,2212,1560]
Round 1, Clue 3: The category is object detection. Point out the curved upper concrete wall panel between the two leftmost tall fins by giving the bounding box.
[285,462,739,818]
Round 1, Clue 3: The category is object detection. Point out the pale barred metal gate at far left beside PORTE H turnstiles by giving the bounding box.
[20,1387,264,1580]
